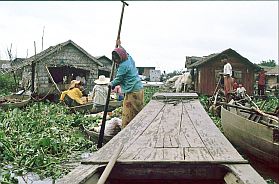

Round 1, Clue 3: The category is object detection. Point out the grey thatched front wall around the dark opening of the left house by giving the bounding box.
[23,44,98,95]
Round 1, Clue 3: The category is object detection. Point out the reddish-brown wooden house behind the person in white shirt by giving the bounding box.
[185,48,259,96]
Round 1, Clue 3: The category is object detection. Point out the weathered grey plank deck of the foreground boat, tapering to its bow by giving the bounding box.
[58,93,265,184]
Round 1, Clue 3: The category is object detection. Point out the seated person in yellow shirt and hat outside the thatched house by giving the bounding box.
[60,80,84,107]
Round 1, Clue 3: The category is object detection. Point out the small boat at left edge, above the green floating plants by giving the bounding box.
[0,94,31,109]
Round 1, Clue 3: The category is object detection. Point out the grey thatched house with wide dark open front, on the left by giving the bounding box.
[17,40,107,96]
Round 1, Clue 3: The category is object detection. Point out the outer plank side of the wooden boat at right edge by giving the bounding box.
[221,107,279,168]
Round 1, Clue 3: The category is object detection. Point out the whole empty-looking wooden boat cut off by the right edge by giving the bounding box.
[221,102,279,168]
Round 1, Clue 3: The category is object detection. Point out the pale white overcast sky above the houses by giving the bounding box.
[0,1,278,72]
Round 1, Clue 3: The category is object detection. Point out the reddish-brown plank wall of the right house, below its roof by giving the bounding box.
[196,56,254,96]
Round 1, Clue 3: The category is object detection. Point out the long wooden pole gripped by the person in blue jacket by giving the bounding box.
[97,1,128,148]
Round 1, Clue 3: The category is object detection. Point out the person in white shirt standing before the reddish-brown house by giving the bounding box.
[221,54,233,102]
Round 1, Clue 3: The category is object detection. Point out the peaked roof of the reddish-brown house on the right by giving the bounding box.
[185,48,260,69]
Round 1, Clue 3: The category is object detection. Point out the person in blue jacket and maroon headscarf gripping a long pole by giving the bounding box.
[109,40,144,128]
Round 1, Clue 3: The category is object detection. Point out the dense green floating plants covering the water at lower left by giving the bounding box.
[0,102,100,183]
